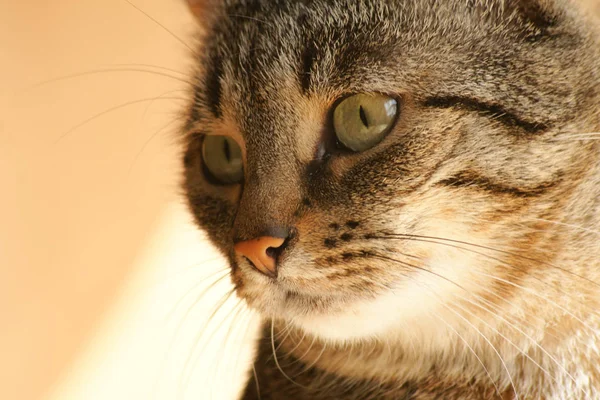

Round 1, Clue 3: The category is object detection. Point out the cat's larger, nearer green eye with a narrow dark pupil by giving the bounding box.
[333,94,398,151]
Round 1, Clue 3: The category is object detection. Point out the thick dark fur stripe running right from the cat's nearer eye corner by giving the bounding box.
[424,96,548,133]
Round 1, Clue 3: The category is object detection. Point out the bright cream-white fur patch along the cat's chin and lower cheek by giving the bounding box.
[294,249,481,342]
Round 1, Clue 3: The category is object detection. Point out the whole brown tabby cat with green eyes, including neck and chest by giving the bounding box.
[183,0,600,400]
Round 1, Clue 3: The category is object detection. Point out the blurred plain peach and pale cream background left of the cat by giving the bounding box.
[0,0,255,400]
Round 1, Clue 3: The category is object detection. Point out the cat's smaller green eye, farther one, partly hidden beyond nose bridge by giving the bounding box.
[202,136,244,185]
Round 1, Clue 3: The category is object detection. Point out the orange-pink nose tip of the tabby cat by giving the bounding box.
[233,236,285,278]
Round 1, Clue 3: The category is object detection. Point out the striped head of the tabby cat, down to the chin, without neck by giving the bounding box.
[184,0,598,340]
